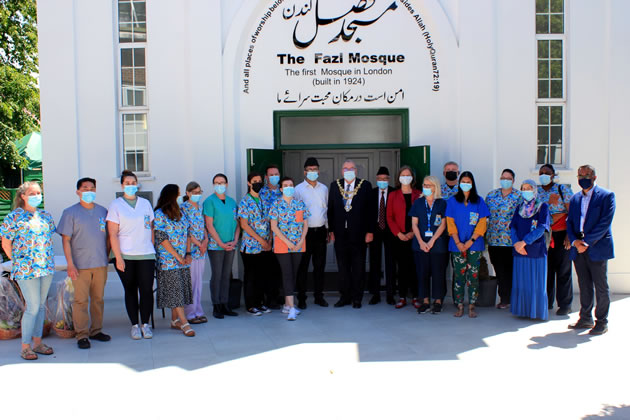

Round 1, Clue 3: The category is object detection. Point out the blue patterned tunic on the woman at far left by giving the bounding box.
[0,207,56,280]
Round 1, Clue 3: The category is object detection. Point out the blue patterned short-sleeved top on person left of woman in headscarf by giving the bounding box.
[486,188,523,246]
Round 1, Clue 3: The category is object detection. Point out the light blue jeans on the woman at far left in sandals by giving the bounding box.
[17,274,53,344]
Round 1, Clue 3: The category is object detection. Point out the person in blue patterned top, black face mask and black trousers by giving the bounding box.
[238,172,271,316]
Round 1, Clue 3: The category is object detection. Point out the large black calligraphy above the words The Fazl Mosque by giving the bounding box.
[282,0,398,49]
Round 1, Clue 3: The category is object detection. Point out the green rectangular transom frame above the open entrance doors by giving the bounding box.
[273,108,409,150]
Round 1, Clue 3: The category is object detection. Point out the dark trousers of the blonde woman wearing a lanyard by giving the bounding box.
[413,251,448,303]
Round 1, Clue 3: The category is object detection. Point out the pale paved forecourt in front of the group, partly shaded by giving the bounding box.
[0,288,630,420]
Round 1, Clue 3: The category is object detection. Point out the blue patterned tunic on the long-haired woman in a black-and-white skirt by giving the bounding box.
[153,209,190,270]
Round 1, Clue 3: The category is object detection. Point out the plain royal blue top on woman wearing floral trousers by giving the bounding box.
[446,197,490,252]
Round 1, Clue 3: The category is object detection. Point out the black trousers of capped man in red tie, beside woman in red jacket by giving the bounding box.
[368,228,396,297]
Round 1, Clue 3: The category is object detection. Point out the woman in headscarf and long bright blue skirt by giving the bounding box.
[510,179,550,320]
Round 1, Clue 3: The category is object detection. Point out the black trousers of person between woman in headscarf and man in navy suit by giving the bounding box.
[547,230,573,308]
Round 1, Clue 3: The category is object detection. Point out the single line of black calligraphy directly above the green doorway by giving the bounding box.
[277,89,405,108]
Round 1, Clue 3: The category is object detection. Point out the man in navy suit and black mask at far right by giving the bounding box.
[567,165,615,335]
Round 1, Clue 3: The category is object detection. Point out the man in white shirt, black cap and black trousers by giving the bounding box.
[295,157,328,309]
